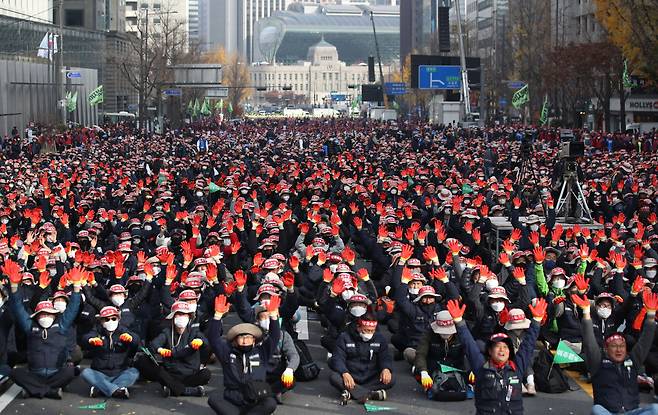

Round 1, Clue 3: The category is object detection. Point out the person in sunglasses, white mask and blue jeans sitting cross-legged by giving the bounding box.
[81,306,139,399]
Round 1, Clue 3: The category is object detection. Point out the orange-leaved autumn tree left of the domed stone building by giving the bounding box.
[204,47,252,112]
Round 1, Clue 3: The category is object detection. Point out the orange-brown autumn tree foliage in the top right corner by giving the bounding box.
[594,0,658,83]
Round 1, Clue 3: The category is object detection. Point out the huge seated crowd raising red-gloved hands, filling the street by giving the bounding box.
[0,119,658,414]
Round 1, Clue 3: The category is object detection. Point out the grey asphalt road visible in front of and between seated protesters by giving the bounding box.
[0,310,604,415]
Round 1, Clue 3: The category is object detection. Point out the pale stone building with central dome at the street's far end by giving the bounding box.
[250,39,392,106]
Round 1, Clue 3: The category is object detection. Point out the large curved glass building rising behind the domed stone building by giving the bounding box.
[254,4,400,65]
